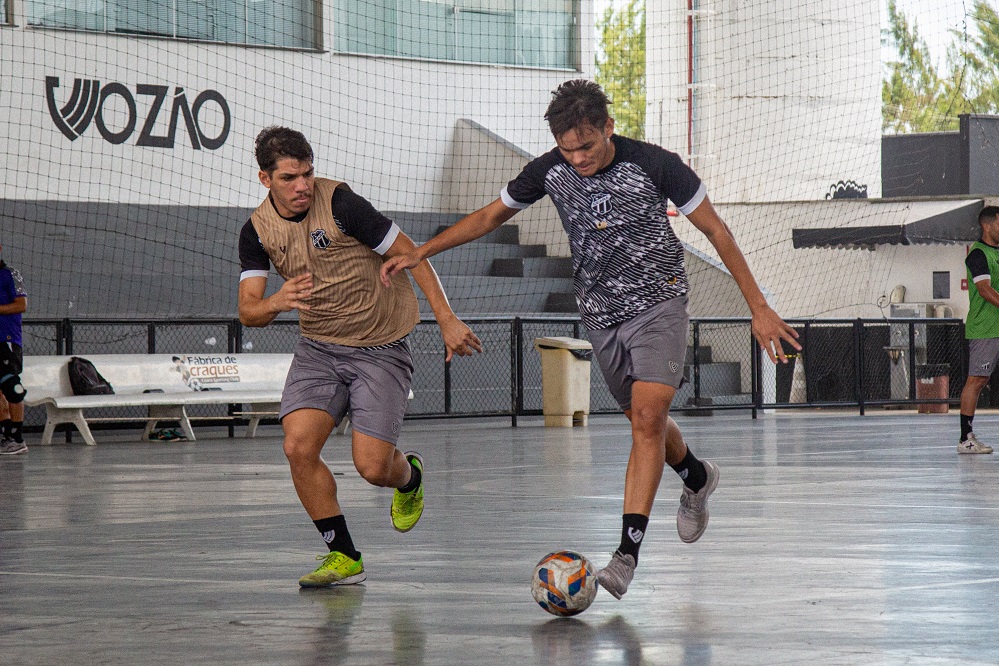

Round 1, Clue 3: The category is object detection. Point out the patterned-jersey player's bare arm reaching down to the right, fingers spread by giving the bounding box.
[687,197,801,363]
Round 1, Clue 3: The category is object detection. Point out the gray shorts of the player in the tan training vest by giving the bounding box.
[280,337,413,444]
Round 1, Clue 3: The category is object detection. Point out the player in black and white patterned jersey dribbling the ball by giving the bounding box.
[381,80,800,599]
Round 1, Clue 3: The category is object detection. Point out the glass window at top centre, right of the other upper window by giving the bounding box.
[334,0,578,69]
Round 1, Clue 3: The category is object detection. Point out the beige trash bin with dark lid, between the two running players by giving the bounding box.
[534,338,593,428]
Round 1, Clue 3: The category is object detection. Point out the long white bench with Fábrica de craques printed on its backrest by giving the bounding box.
[21,354,292,446]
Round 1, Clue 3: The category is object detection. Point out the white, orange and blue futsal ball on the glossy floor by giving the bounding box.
[531,550,597,617]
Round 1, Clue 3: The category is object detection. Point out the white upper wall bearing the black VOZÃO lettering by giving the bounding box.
[0,0,593,210]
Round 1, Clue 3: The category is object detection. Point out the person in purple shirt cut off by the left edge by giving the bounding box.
[0,245,28,455]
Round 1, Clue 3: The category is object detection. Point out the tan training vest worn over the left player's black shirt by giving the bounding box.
[250,178,420,347]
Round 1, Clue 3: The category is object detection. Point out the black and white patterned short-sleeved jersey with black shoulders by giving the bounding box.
[500,134,706,330]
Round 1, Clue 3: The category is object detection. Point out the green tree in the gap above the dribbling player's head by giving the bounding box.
[596,0,645,139]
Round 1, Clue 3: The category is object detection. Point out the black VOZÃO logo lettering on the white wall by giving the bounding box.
[45,76,232,150]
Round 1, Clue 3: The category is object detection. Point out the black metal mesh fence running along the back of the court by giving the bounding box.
[17,317,968,428]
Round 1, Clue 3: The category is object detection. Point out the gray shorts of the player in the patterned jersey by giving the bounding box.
[589,295,690,409]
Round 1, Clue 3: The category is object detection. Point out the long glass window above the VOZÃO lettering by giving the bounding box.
[27,0,320,48]
